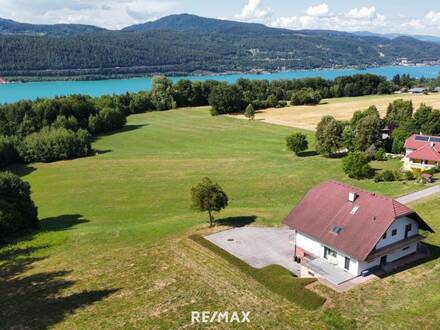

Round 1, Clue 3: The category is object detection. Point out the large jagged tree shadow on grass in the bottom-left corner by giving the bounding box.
[0,246,118,329]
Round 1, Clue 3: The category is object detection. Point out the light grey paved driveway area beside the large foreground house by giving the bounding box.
[205,227,300,274]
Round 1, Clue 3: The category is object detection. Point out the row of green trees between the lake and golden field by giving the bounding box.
[209,74,398,115]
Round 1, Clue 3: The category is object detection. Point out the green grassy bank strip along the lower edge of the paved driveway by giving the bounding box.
[190,235,325,310]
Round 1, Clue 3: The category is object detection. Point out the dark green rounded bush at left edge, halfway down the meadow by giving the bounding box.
[0,172,39,242]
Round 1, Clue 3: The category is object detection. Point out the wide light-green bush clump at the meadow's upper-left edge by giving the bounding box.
[19,128,91,163]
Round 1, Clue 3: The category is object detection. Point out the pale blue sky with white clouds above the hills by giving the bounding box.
[0,0,440,36]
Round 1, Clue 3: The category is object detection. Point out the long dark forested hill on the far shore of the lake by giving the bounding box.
[0,14,440,76]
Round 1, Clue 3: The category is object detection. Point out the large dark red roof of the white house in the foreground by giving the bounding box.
[283,181,432,261]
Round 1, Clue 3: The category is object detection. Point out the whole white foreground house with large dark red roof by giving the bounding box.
[283,181,433,284]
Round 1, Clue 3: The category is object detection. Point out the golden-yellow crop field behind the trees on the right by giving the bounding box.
[234,93,440,130]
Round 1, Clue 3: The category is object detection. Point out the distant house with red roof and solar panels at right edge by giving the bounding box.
[403,134,440,171]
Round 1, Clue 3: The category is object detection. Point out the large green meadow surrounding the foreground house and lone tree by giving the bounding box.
[0,108,440,329]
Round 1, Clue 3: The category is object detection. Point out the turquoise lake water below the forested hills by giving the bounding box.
[0,66,440,103]
